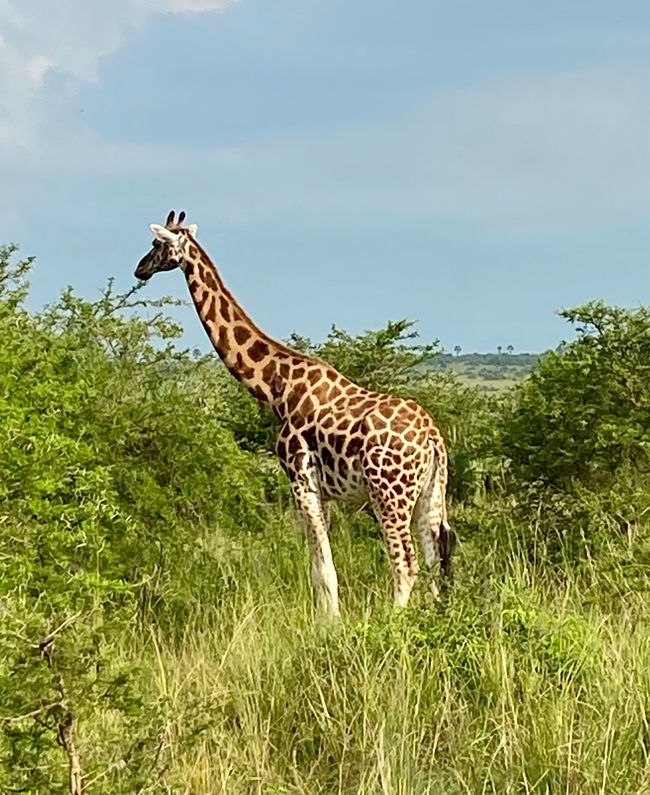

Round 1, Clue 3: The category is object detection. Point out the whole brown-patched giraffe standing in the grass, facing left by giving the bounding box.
[135,210,456,616]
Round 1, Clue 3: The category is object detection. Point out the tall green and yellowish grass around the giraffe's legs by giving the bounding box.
[82,506,650,795]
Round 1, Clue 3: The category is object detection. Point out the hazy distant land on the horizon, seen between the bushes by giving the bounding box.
[432,352,541,391]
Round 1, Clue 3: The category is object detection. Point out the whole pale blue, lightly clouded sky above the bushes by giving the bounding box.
[0,0,650,351]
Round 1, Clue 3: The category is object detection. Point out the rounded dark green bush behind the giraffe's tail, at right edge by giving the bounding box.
[503,302,650,488]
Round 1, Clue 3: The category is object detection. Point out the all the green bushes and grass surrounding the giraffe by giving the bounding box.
[0,247,650,795]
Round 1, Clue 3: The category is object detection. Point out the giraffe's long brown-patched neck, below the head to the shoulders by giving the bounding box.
[185,246,314,416]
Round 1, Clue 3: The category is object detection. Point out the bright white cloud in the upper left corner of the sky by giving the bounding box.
[0,0,238,146]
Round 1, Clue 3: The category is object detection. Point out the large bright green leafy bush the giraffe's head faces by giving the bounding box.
[0,247,277,792]
